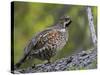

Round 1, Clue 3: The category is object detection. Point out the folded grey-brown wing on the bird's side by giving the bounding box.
[24,29,52,55]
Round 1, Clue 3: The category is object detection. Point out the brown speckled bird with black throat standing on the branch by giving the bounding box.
[14,16,72,69]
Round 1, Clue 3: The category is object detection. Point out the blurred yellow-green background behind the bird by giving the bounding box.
[14,2,97,68]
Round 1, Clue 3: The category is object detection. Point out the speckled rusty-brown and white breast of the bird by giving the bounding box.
[47,31,68,50]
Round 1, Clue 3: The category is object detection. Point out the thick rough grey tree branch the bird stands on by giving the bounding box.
[14,48,97,73]
